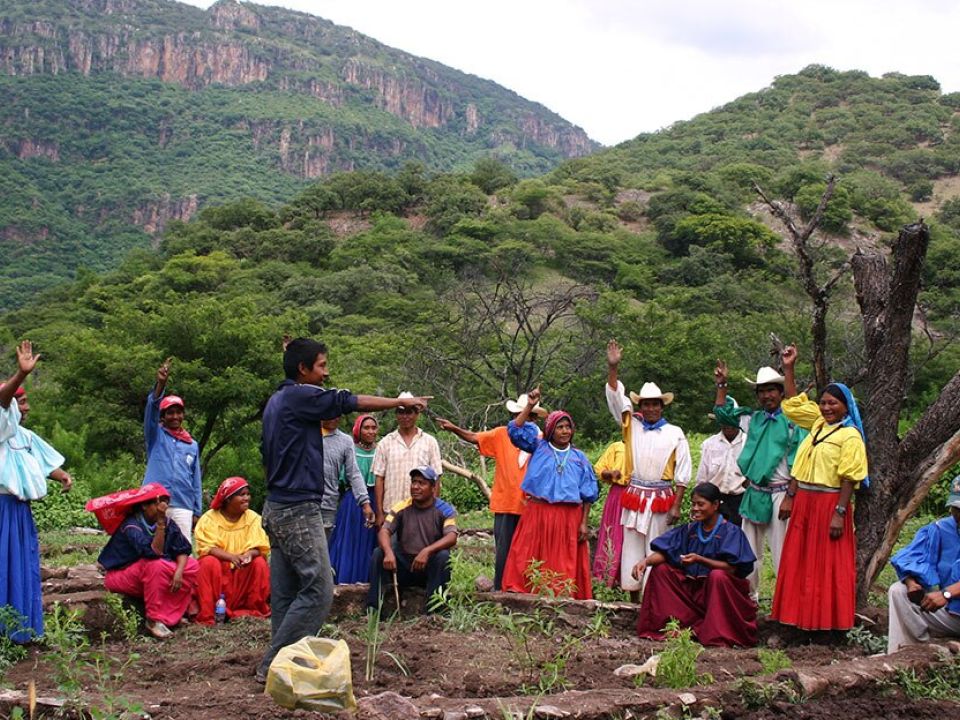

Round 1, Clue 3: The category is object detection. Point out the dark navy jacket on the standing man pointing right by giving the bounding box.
[260,380,357,503]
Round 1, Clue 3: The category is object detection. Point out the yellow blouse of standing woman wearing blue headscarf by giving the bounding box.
[781,393,867,488]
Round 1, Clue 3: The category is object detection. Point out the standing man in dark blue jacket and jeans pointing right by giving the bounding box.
[257,338,429,682]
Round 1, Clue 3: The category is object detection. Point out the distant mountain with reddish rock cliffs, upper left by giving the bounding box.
[0,0,597,306]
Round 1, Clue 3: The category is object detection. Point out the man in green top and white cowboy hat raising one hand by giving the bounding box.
[713,360,807,600]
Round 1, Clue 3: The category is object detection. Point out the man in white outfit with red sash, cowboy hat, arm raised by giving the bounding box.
[605,340,692,602]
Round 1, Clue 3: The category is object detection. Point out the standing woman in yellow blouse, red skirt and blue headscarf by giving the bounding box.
[770,345,867,630]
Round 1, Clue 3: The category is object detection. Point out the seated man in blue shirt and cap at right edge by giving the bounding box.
[887,475,960,653]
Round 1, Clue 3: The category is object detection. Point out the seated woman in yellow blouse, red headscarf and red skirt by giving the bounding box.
[193,477,270,625]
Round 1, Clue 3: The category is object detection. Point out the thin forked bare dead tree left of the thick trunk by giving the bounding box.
[753,175,850,389]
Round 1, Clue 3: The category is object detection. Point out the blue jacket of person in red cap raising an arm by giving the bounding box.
[141,390,203,517]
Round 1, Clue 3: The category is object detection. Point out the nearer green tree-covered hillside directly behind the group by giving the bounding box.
[0,68,960,520]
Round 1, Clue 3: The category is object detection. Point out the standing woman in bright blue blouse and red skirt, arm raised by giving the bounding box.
[503,388,600,600]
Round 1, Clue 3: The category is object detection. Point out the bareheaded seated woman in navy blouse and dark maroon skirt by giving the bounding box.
[633,483,757,647]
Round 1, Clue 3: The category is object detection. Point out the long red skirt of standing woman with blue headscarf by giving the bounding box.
[770,488,857,630]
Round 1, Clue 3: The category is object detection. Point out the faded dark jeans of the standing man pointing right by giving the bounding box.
[258,500,333,675]
